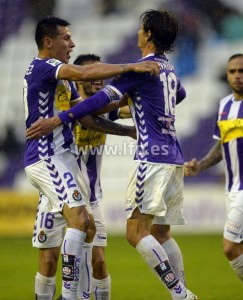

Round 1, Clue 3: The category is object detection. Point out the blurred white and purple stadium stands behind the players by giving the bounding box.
[0,0,243,236]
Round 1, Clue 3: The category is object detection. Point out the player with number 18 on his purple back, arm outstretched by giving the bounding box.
[26,10,198,300]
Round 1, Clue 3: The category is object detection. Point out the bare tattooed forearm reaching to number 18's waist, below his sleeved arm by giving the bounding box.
[79,115,136,139]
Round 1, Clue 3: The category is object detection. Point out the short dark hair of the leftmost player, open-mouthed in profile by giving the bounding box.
[35,16,70,49]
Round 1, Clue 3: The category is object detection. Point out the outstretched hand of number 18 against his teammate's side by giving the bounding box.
[26,116,61,139]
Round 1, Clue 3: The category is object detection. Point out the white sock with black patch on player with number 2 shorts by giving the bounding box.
[61,228,86,300]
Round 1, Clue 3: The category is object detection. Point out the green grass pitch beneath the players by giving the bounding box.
[0,234,243,300]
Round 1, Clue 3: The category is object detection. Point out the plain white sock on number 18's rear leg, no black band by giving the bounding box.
[162,238,186,286]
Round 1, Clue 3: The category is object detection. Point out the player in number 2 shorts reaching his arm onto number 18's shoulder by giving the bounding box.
[23,17,159,300]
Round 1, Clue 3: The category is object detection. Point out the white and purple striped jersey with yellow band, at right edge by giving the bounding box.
[213,94,243,192]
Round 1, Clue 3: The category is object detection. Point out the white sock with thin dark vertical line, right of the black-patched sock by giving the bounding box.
[78,243,93,299]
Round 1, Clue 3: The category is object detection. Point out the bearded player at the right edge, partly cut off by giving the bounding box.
[184,54,243,282]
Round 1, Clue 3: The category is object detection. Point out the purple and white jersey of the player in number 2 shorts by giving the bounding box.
[24,58,80,167]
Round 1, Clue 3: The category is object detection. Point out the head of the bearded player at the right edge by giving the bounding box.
[227,57,243,99]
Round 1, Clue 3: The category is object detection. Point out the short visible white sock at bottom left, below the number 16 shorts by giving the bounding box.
[35,272,56,300]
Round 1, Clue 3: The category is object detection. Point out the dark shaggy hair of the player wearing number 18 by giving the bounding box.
[140,9,178,54]
